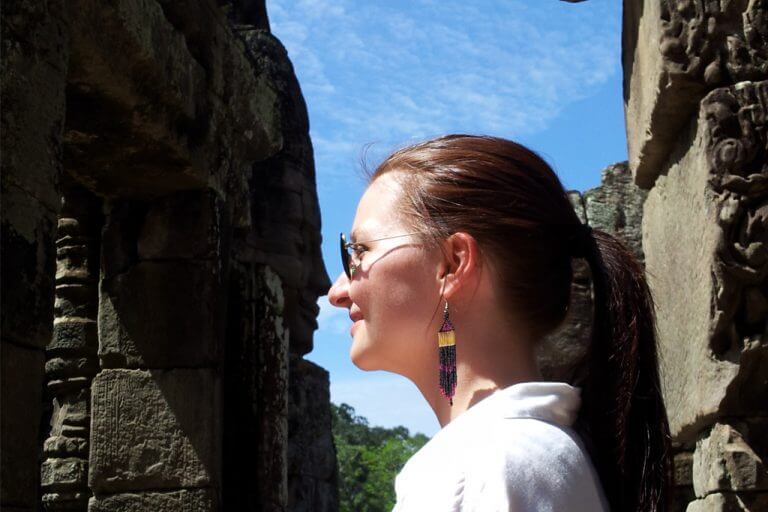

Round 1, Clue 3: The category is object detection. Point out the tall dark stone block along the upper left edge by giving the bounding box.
[0,1,67,356]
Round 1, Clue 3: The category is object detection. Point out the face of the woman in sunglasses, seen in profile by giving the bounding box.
[328,172,442,376]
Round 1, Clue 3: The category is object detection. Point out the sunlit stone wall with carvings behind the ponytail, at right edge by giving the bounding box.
[623,0,768,512]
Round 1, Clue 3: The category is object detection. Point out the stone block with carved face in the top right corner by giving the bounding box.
[622,0,768,188]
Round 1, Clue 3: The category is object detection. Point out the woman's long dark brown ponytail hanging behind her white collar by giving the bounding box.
[576,230,673,512]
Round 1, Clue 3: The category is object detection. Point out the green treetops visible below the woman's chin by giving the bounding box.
[331,403,429,512]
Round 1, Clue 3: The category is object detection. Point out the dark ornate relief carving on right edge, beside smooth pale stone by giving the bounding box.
[702,82,768,355]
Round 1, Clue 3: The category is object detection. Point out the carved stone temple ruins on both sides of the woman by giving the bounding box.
[0,0,768,512]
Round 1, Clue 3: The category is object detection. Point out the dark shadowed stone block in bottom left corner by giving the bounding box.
[0,340,45,508]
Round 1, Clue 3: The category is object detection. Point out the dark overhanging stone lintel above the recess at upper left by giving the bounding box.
[66,0,282,197]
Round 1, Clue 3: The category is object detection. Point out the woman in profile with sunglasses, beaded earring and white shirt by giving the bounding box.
[329,135,672,512]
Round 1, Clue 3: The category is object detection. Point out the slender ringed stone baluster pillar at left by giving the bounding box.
[41,180,102,511]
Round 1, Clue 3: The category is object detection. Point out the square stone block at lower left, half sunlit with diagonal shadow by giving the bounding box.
[88,369,221,496]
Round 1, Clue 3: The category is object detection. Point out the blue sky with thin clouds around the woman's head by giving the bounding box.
[267,0,627,436]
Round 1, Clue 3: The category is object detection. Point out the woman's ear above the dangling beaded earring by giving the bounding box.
[438,232,482,301]
